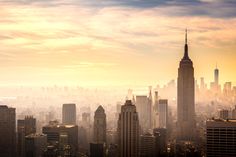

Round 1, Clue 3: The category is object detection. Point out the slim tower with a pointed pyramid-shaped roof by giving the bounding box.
[93,105,106,144]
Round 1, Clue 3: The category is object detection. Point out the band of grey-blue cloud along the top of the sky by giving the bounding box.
[0,0,236,18]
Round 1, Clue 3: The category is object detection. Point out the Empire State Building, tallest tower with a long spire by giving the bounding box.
[177,30,196,141]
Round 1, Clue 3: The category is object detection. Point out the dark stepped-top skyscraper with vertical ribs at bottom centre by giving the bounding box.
[117,100,139,157]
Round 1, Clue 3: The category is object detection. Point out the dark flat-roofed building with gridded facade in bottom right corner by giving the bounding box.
[206,119,236,157]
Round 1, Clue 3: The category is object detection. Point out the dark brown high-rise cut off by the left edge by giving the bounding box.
[0,105,16,157]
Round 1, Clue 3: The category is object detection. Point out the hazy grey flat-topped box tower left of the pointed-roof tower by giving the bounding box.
[62,104,76,125]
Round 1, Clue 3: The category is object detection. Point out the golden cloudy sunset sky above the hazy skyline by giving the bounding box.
[0,0,236,86]
